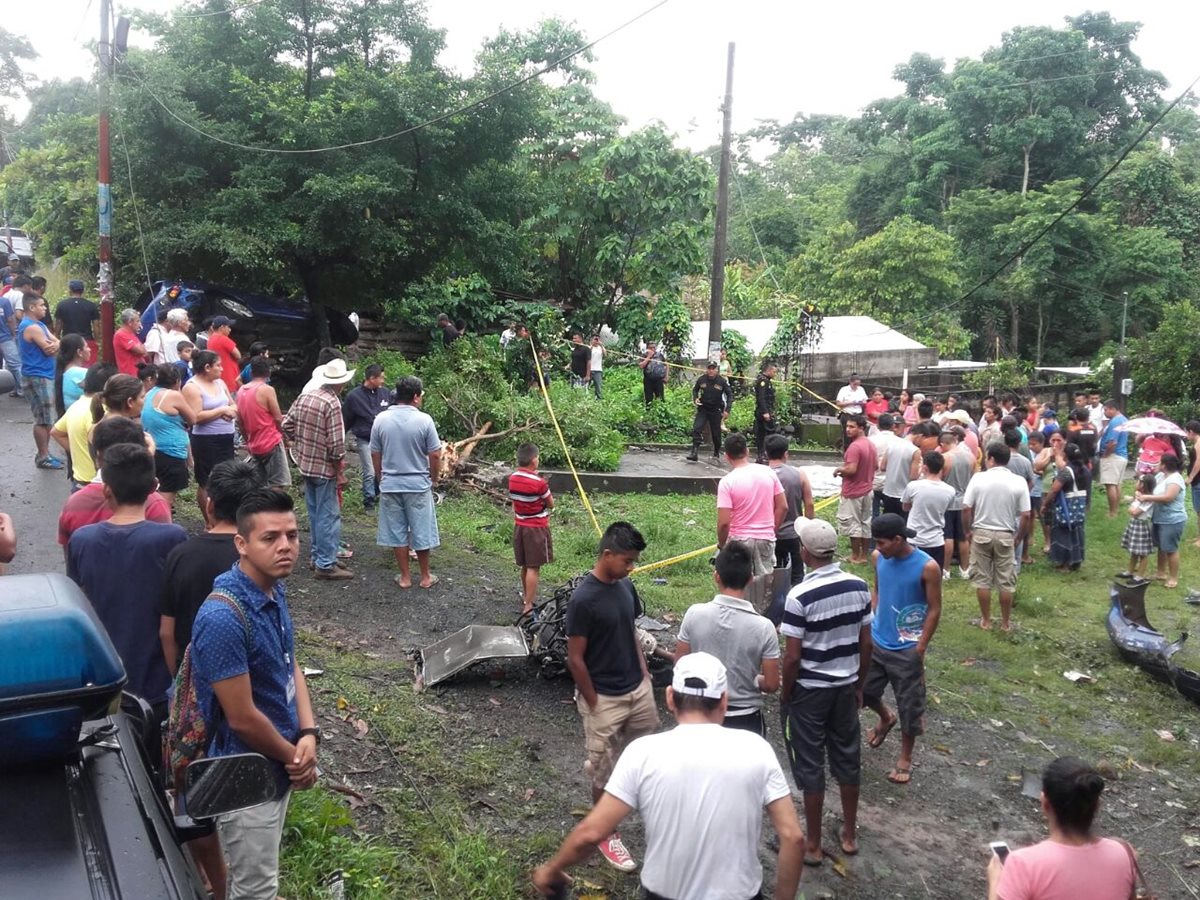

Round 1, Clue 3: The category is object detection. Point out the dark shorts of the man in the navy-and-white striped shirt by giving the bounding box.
[780,683,863,793]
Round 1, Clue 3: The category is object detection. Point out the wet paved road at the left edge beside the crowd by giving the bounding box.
[0,394,70,575]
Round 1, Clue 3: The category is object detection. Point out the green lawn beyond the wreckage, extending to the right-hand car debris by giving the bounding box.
[439,493,1200,775]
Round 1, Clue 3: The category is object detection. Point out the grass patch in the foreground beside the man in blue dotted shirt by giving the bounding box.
[281,635,559,900]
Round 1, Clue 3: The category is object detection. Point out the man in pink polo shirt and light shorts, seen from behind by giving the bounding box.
[716,434,787,576]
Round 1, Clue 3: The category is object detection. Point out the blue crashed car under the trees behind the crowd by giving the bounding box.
[137,280,359,379]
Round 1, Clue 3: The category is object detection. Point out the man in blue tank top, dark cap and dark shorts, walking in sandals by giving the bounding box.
[863,512,942,785]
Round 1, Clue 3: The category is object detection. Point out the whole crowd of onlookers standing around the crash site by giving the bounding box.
[0,278,1180,900]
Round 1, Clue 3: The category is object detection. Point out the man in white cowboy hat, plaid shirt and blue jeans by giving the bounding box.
[282,355,354,581]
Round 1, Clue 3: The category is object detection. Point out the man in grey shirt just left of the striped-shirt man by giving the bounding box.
[676,542,779,737]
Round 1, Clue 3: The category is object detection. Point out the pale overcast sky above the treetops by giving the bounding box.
[4,0,1200,149]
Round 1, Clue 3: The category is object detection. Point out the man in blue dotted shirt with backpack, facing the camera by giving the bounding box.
[192,488,320,900]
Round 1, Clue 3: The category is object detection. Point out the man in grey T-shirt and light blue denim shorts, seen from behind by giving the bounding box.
[371,376,442,588]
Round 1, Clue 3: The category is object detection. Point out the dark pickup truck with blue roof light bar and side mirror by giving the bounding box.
[0,575,275,900]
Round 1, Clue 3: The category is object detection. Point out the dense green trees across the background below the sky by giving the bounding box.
[0,7,1200,393]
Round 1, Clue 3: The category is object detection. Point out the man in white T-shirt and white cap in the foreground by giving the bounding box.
[533,653,804,900]
